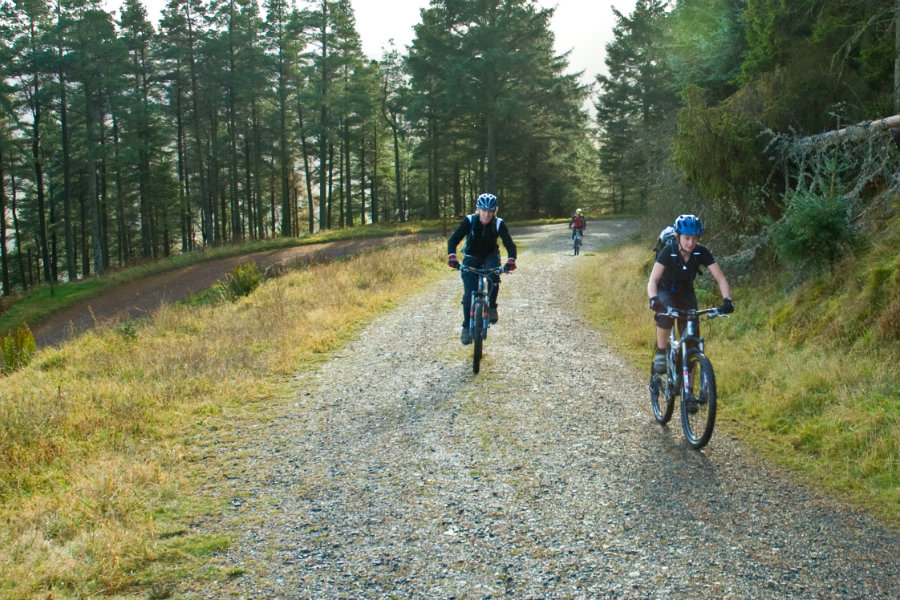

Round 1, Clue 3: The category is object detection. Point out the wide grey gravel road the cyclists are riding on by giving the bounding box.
[183,221,900,599]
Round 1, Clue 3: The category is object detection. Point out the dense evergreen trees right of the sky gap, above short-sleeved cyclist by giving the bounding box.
[597,0,900,264]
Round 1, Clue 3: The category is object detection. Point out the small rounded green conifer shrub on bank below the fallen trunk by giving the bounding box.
[769,190,858,268]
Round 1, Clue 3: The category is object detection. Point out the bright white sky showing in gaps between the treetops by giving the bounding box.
[106,0,635,84]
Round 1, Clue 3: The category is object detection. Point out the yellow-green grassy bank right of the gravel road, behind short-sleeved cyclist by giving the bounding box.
[577,220,900,525]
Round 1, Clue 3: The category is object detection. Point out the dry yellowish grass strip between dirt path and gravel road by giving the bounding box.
[0,242,445,599]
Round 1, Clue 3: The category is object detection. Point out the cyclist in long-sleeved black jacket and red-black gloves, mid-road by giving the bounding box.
[447,194,516,344]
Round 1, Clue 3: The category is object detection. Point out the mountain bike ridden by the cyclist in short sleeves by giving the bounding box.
[650,307,728,450]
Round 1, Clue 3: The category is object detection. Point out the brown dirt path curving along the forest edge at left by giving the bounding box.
[32,235,432,348]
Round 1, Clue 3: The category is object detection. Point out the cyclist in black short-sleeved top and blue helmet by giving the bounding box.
[647,215,734,373]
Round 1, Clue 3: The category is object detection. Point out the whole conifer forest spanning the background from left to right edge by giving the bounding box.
[0,0,900,295]
